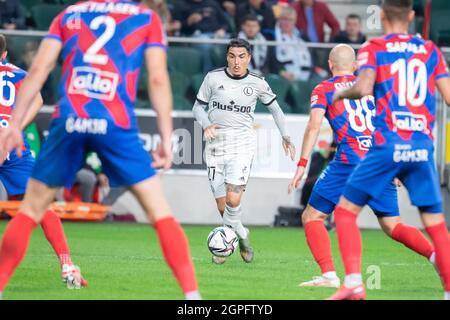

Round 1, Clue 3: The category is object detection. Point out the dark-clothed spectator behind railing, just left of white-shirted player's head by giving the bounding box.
[174,0,229,73]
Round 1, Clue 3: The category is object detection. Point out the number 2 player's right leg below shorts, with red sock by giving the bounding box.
[131,176,201,300]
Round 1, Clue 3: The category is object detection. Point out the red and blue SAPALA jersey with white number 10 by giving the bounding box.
[358,33,449,144]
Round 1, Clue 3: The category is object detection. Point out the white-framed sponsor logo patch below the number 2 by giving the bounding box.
[69,67,119,101]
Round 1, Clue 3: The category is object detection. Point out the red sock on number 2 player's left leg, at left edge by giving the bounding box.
[0,213,37,292]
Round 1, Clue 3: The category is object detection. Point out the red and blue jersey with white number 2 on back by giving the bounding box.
[47,0,166,128]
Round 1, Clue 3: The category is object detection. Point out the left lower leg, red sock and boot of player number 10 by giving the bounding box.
[329,197,366,300]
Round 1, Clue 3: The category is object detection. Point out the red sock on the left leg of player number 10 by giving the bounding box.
[334,206,362,275]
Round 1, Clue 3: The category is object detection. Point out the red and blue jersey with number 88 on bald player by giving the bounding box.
[311,75,375,164]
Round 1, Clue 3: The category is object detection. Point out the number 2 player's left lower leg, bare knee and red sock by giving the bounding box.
[0,179,55,294]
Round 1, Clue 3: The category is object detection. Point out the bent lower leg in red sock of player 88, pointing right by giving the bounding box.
[378,217,435,265]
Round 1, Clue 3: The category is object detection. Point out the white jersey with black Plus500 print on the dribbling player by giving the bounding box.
[197,68,276,157]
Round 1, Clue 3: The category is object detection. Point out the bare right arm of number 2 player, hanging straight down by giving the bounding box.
[145,47,173,170]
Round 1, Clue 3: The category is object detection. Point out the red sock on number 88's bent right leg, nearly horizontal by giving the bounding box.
[392,223,434,259]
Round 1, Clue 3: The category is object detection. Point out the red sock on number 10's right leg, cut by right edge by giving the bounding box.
[426,222,450,292]
